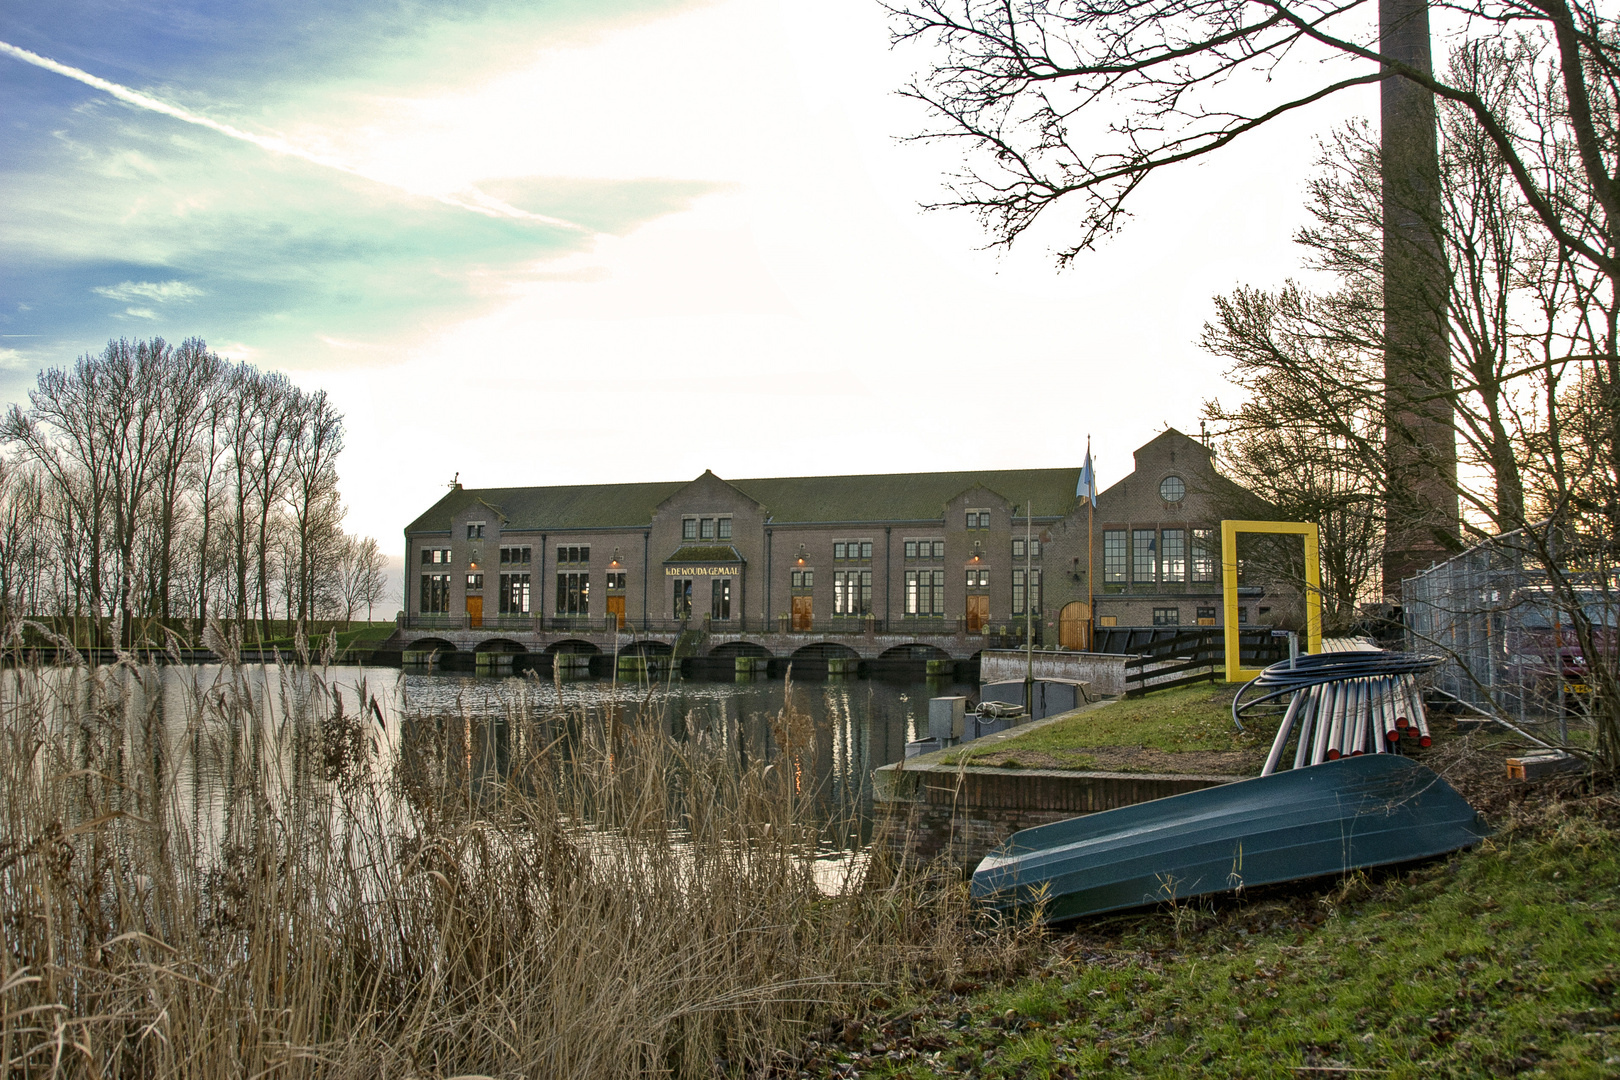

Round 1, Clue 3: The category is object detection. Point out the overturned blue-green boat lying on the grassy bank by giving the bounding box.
[972,755,1489,923]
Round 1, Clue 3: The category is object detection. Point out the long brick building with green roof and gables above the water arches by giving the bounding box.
[405,431,1260,648]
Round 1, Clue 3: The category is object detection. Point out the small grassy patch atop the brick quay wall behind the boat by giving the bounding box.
[951,683,1277,772]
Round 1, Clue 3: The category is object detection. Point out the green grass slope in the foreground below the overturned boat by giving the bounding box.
[804,790,1620,1080]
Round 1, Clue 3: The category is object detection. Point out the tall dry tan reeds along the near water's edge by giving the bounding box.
[0,647,1024,1077]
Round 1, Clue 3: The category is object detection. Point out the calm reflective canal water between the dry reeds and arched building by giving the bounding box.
[0,664,977,840]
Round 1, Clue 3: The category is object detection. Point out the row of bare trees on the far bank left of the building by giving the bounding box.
[0,338,386,643]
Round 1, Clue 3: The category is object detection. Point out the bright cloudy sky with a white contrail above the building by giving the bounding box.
[0,0,1375,592]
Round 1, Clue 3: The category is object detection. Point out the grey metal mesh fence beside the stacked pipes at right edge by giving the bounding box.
[1401,529,1620,738]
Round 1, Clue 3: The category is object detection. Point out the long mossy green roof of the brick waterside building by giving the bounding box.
[405,466,1081,533]
